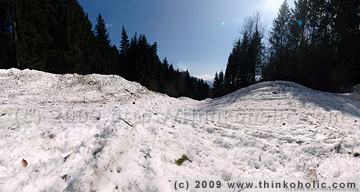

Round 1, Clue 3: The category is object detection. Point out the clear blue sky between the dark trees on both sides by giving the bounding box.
[79,0,293,79]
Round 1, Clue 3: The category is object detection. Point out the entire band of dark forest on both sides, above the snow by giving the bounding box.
[0,0,360,100]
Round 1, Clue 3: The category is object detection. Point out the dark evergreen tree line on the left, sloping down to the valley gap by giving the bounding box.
[0,0,210,100]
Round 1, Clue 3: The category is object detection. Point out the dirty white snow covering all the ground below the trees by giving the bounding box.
[0,69,360,192]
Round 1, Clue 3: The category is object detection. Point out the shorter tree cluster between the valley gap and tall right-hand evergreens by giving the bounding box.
[213,14,265,97]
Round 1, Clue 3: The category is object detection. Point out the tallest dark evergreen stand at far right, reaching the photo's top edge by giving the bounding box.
[263,0,360,91]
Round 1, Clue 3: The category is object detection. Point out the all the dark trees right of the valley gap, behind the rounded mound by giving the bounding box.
[213,0,360,96]
